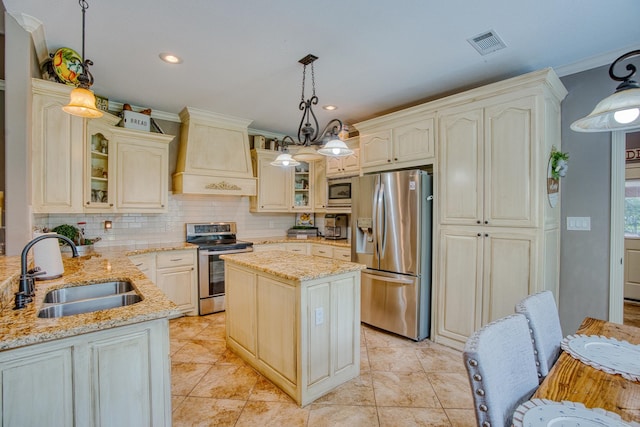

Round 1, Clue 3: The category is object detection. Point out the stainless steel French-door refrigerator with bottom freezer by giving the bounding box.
[351,170,433,341]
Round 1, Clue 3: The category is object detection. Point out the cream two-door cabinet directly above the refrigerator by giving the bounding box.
[355,112,435,173]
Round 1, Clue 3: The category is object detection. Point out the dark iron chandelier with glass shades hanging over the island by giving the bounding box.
[271,54,353,167]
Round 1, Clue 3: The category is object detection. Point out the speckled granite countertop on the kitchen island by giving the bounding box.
[220,250,366,282]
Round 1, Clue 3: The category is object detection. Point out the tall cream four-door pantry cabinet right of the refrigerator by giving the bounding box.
[432,69,567,349]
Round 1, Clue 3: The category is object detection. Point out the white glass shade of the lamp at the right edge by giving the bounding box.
[571,89,640,132]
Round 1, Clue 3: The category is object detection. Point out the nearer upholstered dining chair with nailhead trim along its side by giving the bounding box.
[462,314,538,427]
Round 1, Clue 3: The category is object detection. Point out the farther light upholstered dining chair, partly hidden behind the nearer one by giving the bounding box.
[515,291,562,382]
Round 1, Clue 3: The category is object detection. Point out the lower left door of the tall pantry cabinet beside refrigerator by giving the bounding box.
[437,227,482,347]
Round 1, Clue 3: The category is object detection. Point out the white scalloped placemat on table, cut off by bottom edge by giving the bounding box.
[513,399,639,427]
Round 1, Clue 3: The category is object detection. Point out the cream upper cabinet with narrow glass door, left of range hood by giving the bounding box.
[85,114,173,213]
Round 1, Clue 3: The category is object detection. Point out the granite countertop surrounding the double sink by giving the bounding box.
[0,242,196,351]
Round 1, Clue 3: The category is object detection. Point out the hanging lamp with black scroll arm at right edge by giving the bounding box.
[571,50,640,132]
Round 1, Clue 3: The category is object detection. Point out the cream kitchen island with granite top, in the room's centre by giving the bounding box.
[222,250,364,406]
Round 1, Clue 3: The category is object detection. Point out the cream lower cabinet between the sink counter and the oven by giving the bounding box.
[129,249,198,316]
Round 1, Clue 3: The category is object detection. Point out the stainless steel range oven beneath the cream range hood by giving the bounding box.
[187,222,253,316]
